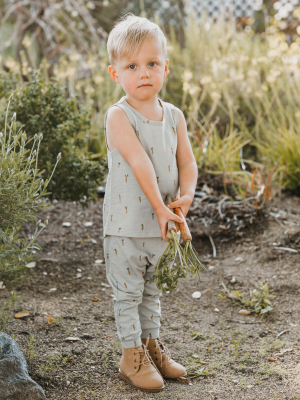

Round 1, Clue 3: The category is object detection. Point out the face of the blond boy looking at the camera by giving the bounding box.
[108,38,169,101]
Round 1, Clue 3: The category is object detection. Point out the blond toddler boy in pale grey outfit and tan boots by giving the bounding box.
[103,14,197,392]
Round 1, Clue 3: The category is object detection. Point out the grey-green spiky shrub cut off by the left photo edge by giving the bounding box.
[0,99,59,288]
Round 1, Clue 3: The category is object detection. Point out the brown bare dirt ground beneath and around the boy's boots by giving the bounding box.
[0,186,300,400]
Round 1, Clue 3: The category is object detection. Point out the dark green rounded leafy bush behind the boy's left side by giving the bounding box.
[3,71,104,205]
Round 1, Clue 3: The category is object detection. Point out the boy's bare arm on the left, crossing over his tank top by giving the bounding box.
[106,107,181,241]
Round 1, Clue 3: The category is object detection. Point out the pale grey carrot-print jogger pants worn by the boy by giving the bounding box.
[103,235,173,348]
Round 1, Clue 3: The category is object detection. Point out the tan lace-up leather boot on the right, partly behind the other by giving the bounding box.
[142,339,187,380]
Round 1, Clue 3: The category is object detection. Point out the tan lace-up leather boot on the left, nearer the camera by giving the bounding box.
[119,345,165,392]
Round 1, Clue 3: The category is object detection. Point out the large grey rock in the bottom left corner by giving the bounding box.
[0,332,46,400]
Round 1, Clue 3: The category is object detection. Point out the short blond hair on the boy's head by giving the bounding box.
[107,13,167,64]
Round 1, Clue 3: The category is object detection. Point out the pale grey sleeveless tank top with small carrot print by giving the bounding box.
[103,96,179,238]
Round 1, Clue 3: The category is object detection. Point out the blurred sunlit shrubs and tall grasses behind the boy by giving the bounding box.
[0,0,300,284]
